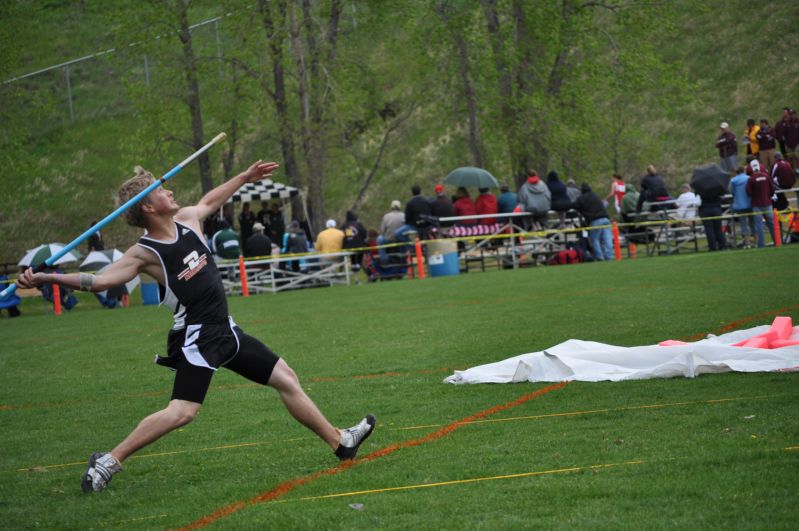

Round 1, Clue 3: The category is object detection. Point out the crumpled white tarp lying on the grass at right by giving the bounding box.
[444,326,799,384]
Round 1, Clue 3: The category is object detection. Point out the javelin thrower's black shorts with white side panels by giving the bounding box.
[164,321,280,404]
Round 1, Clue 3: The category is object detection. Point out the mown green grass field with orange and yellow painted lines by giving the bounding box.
[0,245,799,529]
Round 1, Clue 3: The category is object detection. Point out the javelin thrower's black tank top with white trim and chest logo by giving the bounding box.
[139,222,228,329]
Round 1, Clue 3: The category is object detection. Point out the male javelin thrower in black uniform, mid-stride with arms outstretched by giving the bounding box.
[17,160,375,492]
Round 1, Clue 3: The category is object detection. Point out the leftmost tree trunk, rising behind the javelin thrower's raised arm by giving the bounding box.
[176,1,214,194]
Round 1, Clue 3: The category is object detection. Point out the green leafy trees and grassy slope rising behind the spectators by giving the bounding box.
[0,0,799,262]
